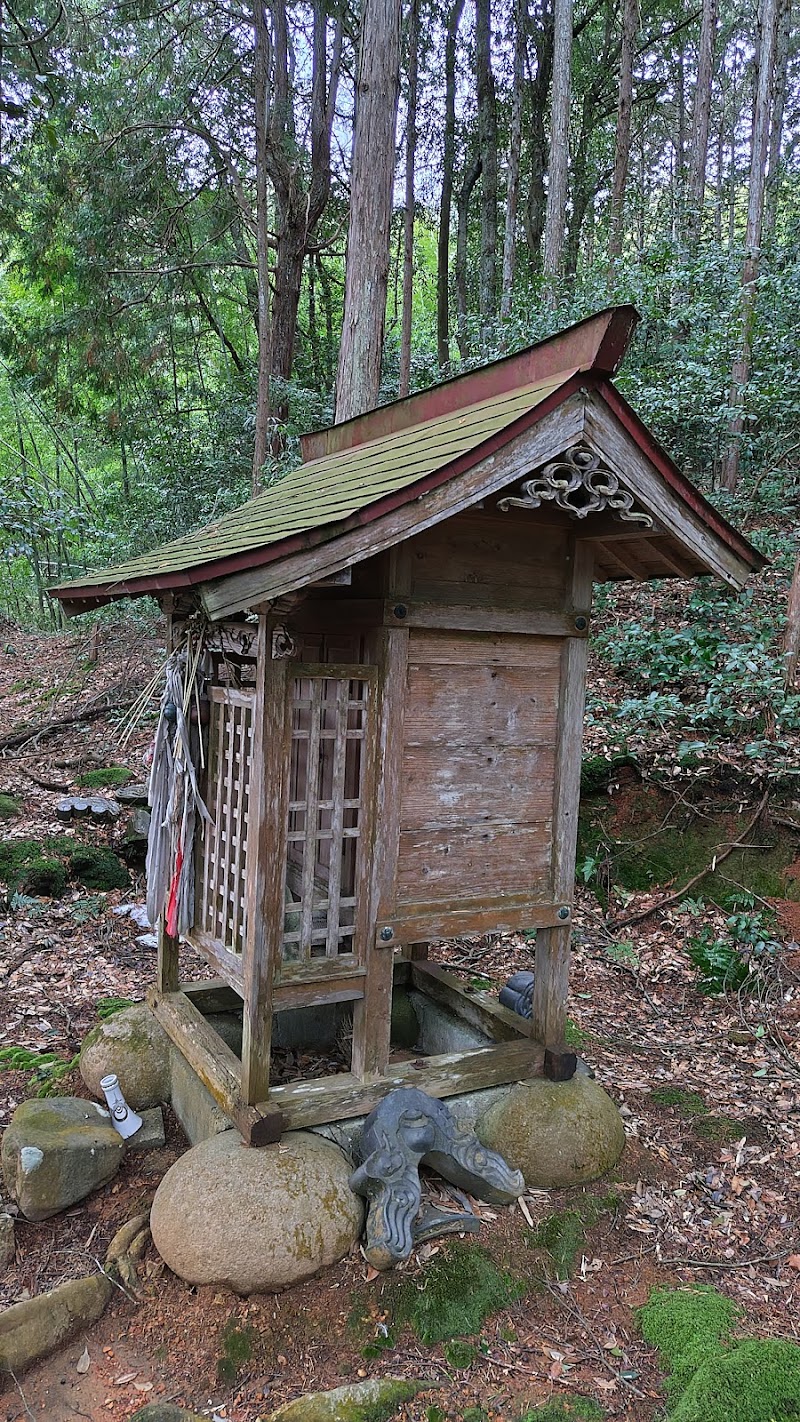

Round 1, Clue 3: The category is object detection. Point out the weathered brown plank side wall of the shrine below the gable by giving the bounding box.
[396,512,568,920]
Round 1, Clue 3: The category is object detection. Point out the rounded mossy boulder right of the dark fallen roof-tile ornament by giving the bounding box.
[475,1072,625,1190]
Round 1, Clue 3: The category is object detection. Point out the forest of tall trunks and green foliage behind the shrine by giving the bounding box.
[0,0,800,776]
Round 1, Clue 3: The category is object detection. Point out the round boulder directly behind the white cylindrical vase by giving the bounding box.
[80,1003,169,1111]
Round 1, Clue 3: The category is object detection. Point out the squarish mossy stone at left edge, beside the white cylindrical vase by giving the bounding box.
[1,1096,125,1220]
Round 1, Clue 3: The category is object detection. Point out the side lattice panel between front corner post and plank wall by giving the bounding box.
[283,667,371,964]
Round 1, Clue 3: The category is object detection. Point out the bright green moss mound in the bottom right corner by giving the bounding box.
[638,1287,800,1422]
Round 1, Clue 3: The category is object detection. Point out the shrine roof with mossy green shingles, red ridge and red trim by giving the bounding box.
[51,307,764,616]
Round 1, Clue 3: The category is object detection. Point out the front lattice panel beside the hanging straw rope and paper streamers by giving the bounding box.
[195,687,254,956]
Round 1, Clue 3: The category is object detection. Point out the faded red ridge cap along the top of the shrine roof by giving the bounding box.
[300,306,639,464]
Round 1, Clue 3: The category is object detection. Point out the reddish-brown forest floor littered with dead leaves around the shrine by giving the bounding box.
[0,626,800,1422]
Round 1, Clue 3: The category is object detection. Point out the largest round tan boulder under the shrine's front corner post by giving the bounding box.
[151,1130,362,1294]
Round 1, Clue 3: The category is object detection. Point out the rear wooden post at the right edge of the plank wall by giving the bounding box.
[531,538,594,1051]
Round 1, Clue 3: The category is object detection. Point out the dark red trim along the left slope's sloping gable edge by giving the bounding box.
[47,371,585,604]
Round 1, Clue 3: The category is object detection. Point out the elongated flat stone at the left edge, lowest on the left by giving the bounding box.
[0,1274,114,1372]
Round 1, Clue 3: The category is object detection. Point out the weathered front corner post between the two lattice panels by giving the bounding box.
[240,613,288,1106]
